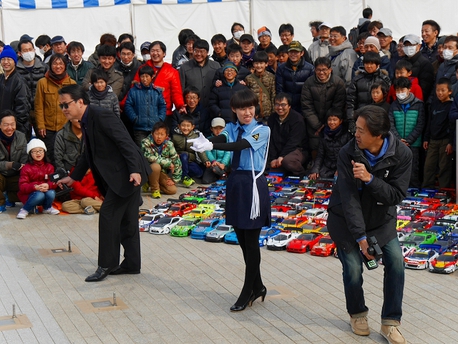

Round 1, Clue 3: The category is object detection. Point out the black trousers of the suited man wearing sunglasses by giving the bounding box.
[99,187,141,270]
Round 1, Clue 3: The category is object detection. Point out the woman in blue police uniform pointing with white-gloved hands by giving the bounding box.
[193,89,270,312]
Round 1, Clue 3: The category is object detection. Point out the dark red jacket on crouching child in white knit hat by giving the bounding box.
[17,160,57,204]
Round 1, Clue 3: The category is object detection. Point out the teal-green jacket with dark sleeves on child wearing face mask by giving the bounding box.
[389,98,425,147]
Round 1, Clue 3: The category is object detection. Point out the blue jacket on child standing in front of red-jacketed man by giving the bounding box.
[124,83,166,131]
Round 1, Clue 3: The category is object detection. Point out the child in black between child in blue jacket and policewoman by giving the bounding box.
[172,86,211,136]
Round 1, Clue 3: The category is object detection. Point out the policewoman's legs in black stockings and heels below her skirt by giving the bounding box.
[234,227,264,304]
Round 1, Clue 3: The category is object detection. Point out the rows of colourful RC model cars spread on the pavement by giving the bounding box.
[139,174,458,273]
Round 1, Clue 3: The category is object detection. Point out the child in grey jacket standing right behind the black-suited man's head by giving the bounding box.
[87,68,121,117]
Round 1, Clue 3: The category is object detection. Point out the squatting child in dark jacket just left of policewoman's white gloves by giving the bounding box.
[172,115,211,187]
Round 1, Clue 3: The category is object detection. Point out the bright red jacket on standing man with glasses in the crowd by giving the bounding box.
[134,60,184,116]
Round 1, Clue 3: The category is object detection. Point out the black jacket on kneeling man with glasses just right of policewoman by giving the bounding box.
[267,109,306,162]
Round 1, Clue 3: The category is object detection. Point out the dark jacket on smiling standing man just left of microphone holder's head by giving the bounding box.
[301,74,347,131]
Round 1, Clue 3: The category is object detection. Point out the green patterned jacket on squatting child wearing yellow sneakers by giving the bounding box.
[142,134,182,183]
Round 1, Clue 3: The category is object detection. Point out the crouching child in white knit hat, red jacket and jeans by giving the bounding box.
[16,139,59,219]
